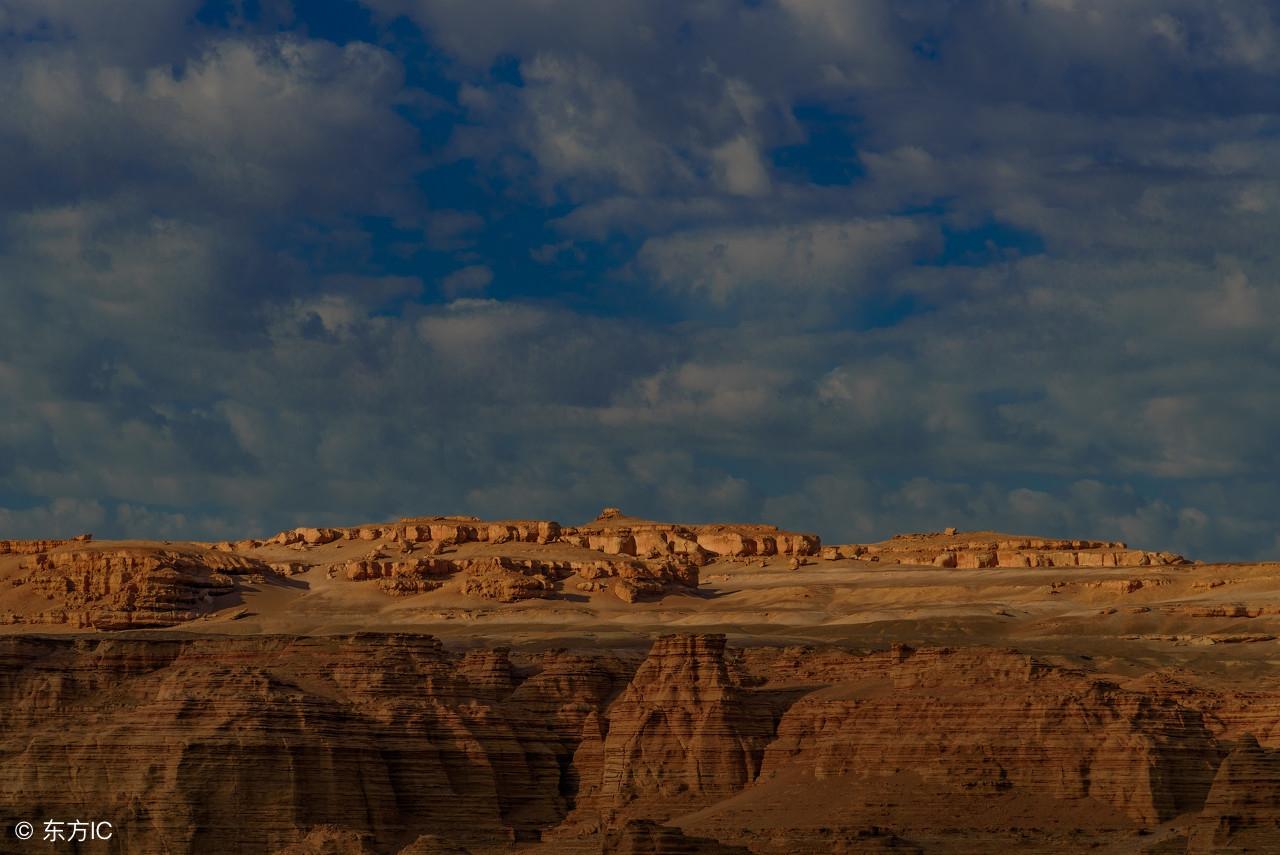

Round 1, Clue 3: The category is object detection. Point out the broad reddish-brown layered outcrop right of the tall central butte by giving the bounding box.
[763,650,1221,826]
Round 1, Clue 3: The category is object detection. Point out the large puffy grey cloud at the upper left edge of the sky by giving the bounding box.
[0,36,415,214]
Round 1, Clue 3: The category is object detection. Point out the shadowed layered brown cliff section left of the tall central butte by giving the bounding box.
[0,635,637,855]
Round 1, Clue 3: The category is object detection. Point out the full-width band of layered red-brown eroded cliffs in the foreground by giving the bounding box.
[0,634,1264,855]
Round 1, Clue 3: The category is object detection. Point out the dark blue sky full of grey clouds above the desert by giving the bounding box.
[0,0,1280,559]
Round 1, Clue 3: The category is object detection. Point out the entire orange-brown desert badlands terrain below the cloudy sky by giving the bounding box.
[0,508,1280,855]
